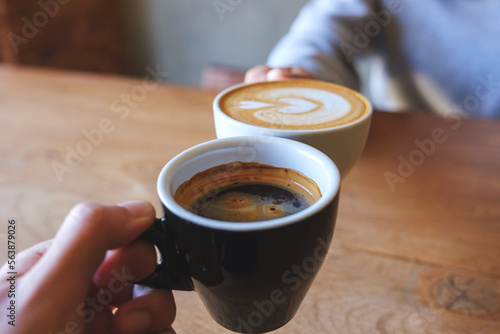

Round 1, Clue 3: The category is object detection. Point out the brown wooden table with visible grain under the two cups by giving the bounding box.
[0,66,500,334]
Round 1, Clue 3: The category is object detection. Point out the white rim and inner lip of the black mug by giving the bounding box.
[157,136,341,232]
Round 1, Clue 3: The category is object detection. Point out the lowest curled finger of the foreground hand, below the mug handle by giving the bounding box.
[113,286,176,334]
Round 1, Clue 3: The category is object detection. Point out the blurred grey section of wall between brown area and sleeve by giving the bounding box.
[118,0,307,86]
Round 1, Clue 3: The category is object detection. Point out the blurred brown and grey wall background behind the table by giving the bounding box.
[0,0,308,88]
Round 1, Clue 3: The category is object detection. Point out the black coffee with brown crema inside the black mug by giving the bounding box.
[174,161,321,222]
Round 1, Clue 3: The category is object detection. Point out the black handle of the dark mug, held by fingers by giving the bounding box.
[134,218,193,291]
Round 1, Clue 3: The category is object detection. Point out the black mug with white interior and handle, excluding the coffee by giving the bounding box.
[138,137,340,333]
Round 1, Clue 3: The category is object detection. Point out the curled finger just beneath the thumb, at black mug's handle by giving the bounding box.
[93,241,157,306]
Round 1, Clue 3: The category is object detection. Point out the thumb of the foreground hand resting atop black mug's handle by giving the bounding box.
[20,201,154,306]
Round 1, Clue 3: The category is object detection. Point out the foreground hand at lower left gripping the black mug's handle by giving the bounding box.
[0,201,175,334]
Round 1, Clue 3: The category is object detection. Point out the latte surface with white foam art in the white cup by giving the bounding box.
[218,80,370,130]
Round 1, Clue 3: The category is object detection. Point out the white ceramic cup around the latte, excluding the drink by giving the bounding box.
[213,80,372,178]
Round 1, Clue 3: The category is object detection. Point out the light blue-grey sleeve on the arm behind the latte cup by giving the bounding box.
[267,0,375,90]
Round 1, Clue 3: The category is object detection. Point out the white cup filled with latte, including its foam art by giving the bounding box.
[213,80,372,178]
